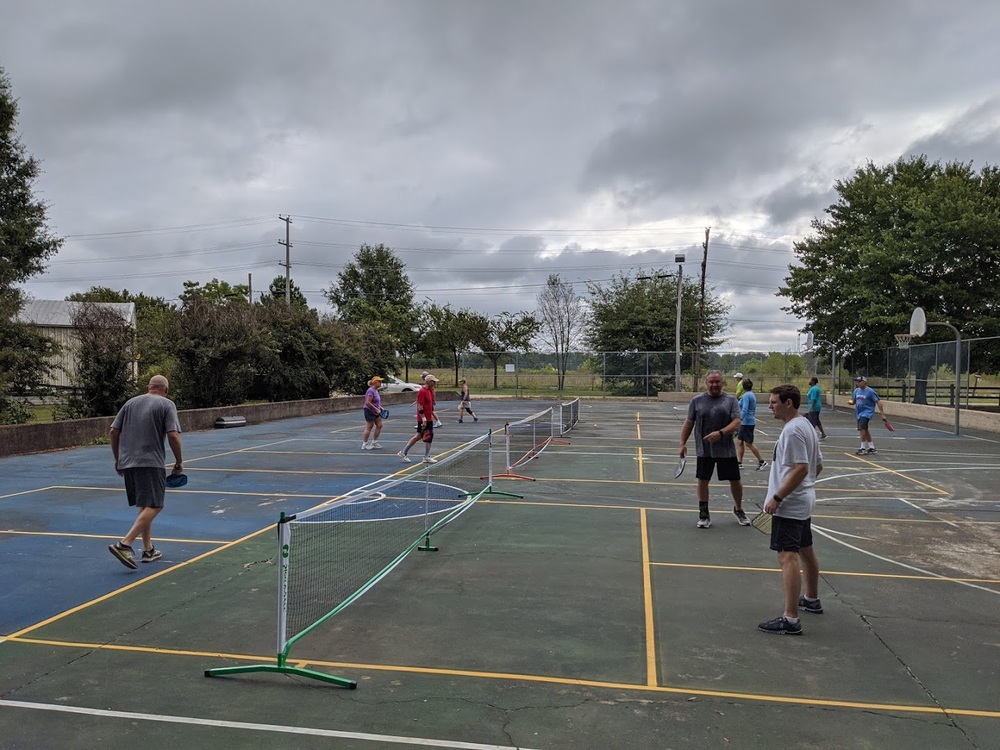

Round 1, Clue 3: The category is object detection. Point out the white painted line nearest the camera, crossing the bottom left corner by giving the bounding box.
[0,700,544,750]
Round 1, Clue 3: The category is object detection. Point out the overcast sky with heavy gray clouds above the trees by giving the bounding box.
[0,0,1000,351]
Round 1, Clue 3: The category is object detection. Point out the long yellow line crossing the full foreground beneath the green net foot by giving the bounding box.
[7,634,1000,719]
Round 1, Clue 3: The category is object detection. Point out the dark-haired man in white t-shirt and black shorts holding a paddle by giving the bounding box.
[757,385,823,635]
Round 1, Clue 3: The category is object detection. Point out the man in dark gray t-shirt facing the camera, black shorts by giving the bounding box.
[680,370,750,529]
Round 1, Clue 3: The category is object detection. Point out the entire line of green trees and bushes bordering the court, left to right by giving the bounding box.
[0,68,1000,423]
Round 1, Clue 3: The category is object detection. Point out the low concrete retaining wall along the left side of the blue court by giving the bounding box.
[0,391,457,456]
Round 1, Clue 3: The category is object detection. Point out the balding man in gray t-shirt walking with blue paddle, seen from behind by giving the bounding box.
[108,375,184,570]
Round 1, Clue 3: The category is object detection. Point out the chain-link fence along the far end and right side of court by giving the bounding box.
[402,338,1000,410]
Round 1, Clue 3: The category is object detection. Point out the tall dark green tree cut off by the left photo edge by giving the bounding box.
[0,68,62,423]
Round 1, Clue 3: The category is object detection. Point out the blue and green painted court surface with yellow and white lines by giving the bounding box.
[0,398,1000,750]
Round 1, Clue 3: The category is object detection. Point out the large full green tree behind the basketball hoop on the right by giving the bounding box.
[779,156,1000,400]
